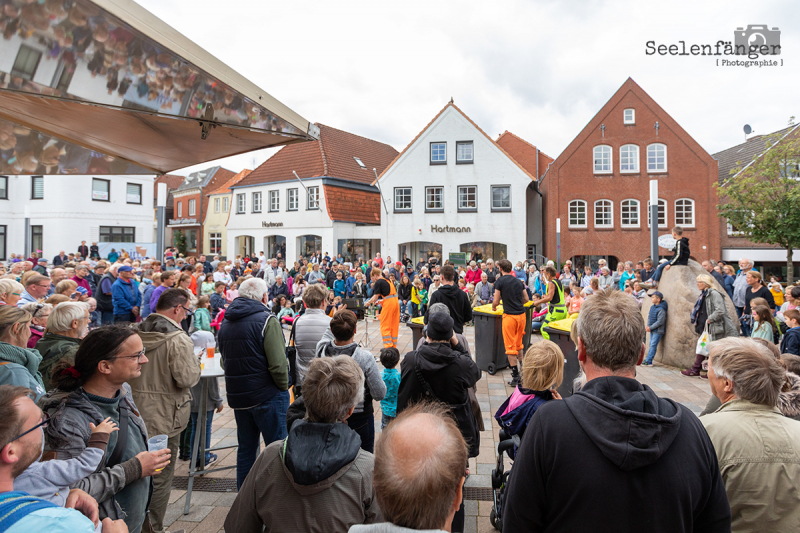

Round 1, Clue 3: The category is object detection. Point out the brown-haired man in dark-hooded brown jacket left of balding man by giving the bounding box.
[225,355,380,533]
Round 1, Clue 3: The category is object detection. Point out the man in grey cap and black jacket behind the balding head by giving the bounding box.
[397,312,481,531]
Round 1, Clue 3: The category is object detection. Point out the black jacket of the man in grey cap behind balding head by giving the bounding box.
[397,343,481,457]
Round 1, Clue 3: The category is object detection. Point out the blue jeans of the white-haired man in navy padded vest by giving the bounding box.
[233,391,289,488]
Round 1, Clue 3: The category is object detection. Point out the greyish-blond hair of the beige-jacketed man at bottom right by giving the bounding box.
[708,337,786,407]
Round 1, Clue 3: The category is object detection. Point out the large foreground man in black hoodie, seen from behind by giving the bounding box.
[503,291,731,533]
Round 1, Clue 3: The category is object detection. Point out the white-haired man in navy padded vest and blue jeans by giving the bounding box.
[217,278,289,488]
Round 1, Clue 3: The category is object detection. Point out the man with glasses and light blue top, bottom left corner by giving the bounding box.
[0,385,128,533]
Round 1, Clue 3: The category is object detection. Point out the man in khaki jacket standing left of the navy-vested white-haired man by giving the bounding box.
[129,289,200,532]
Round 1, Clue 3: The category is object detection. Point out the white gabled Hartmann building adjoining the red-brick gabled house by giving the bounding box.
[378,101,552,263]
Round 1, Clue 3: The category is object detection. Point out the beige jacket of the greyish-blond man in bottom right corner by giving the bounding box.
[700,400,800,533]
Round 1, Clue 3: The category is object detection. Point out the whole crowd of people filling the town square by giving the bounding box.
[0,237,800,533]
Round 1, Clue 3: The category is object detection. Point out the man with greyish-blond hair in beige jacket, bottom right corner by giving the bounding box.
[701,337,800,533]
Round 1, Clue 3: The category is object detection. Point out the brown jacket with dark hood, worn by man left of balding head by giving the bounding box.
[225,420,381,533]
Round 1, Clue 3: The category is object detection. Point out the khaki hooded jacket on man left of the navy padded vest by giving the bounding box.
[129,313,200,437]
